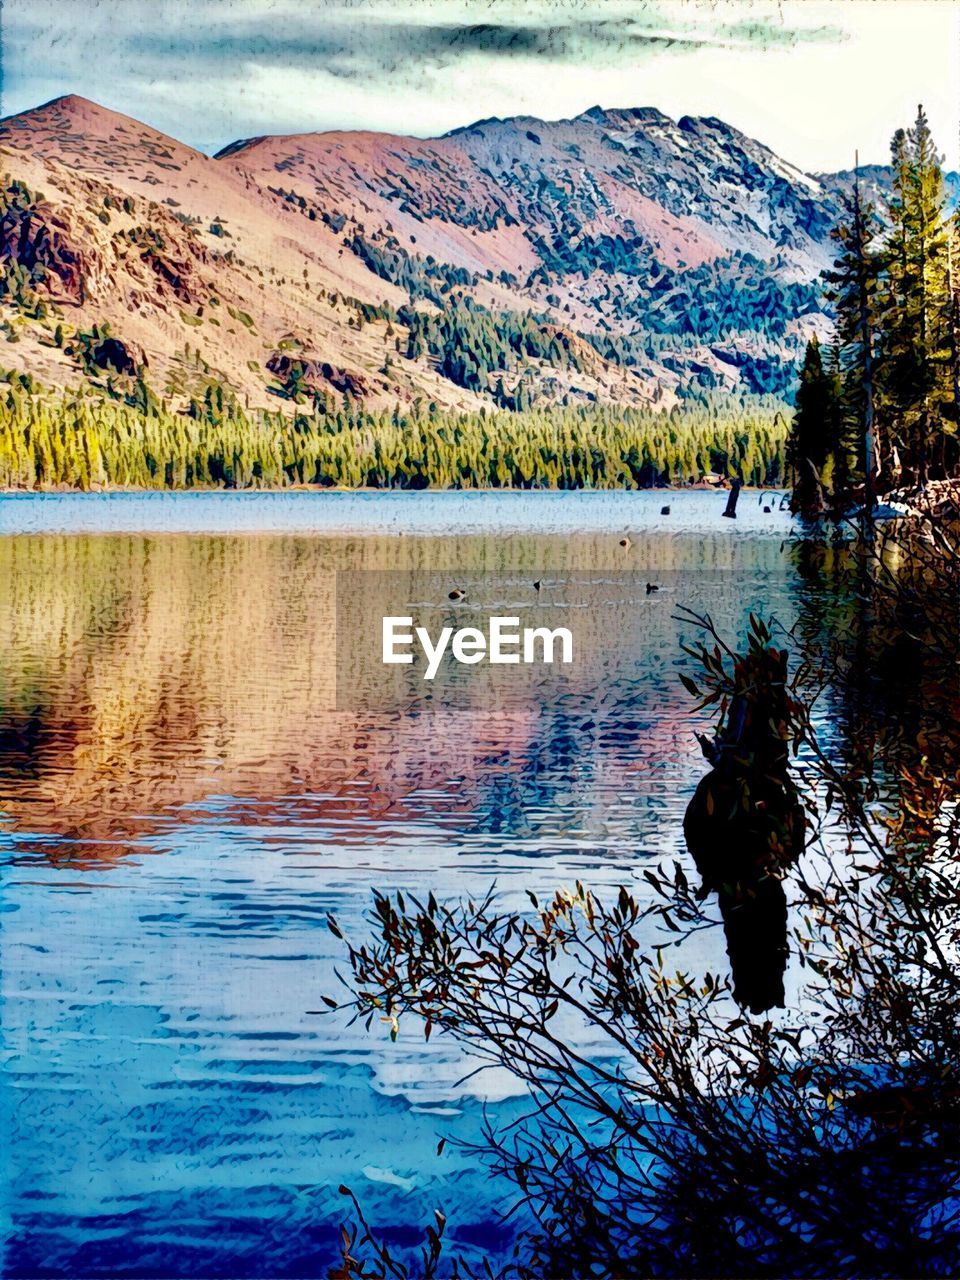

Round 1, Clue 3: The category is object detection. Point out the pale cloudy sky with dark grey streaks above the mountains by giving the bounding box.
[1,0,960,169]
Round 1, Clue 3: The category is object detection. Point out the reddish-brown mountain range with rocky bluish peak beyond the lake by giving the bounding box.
[0,96,916,408]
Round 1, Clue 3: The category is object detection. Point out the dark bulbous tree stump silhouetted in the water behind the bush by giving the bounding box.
[684,649,805,1014]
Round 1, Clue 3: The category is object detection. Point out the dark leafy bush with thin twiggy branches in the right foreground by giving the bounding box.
[328,521,960,1280]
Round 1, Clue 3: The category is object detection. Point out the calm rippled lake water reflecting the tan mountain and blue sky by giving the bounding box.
[0,493,829,1276]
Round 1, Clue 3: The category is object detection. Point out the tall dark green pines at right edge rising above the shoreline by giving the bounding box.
[788,108,960,511]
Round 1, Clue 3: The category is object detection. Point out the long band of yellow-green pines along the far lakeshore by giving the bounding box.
[0,374,786,489]
